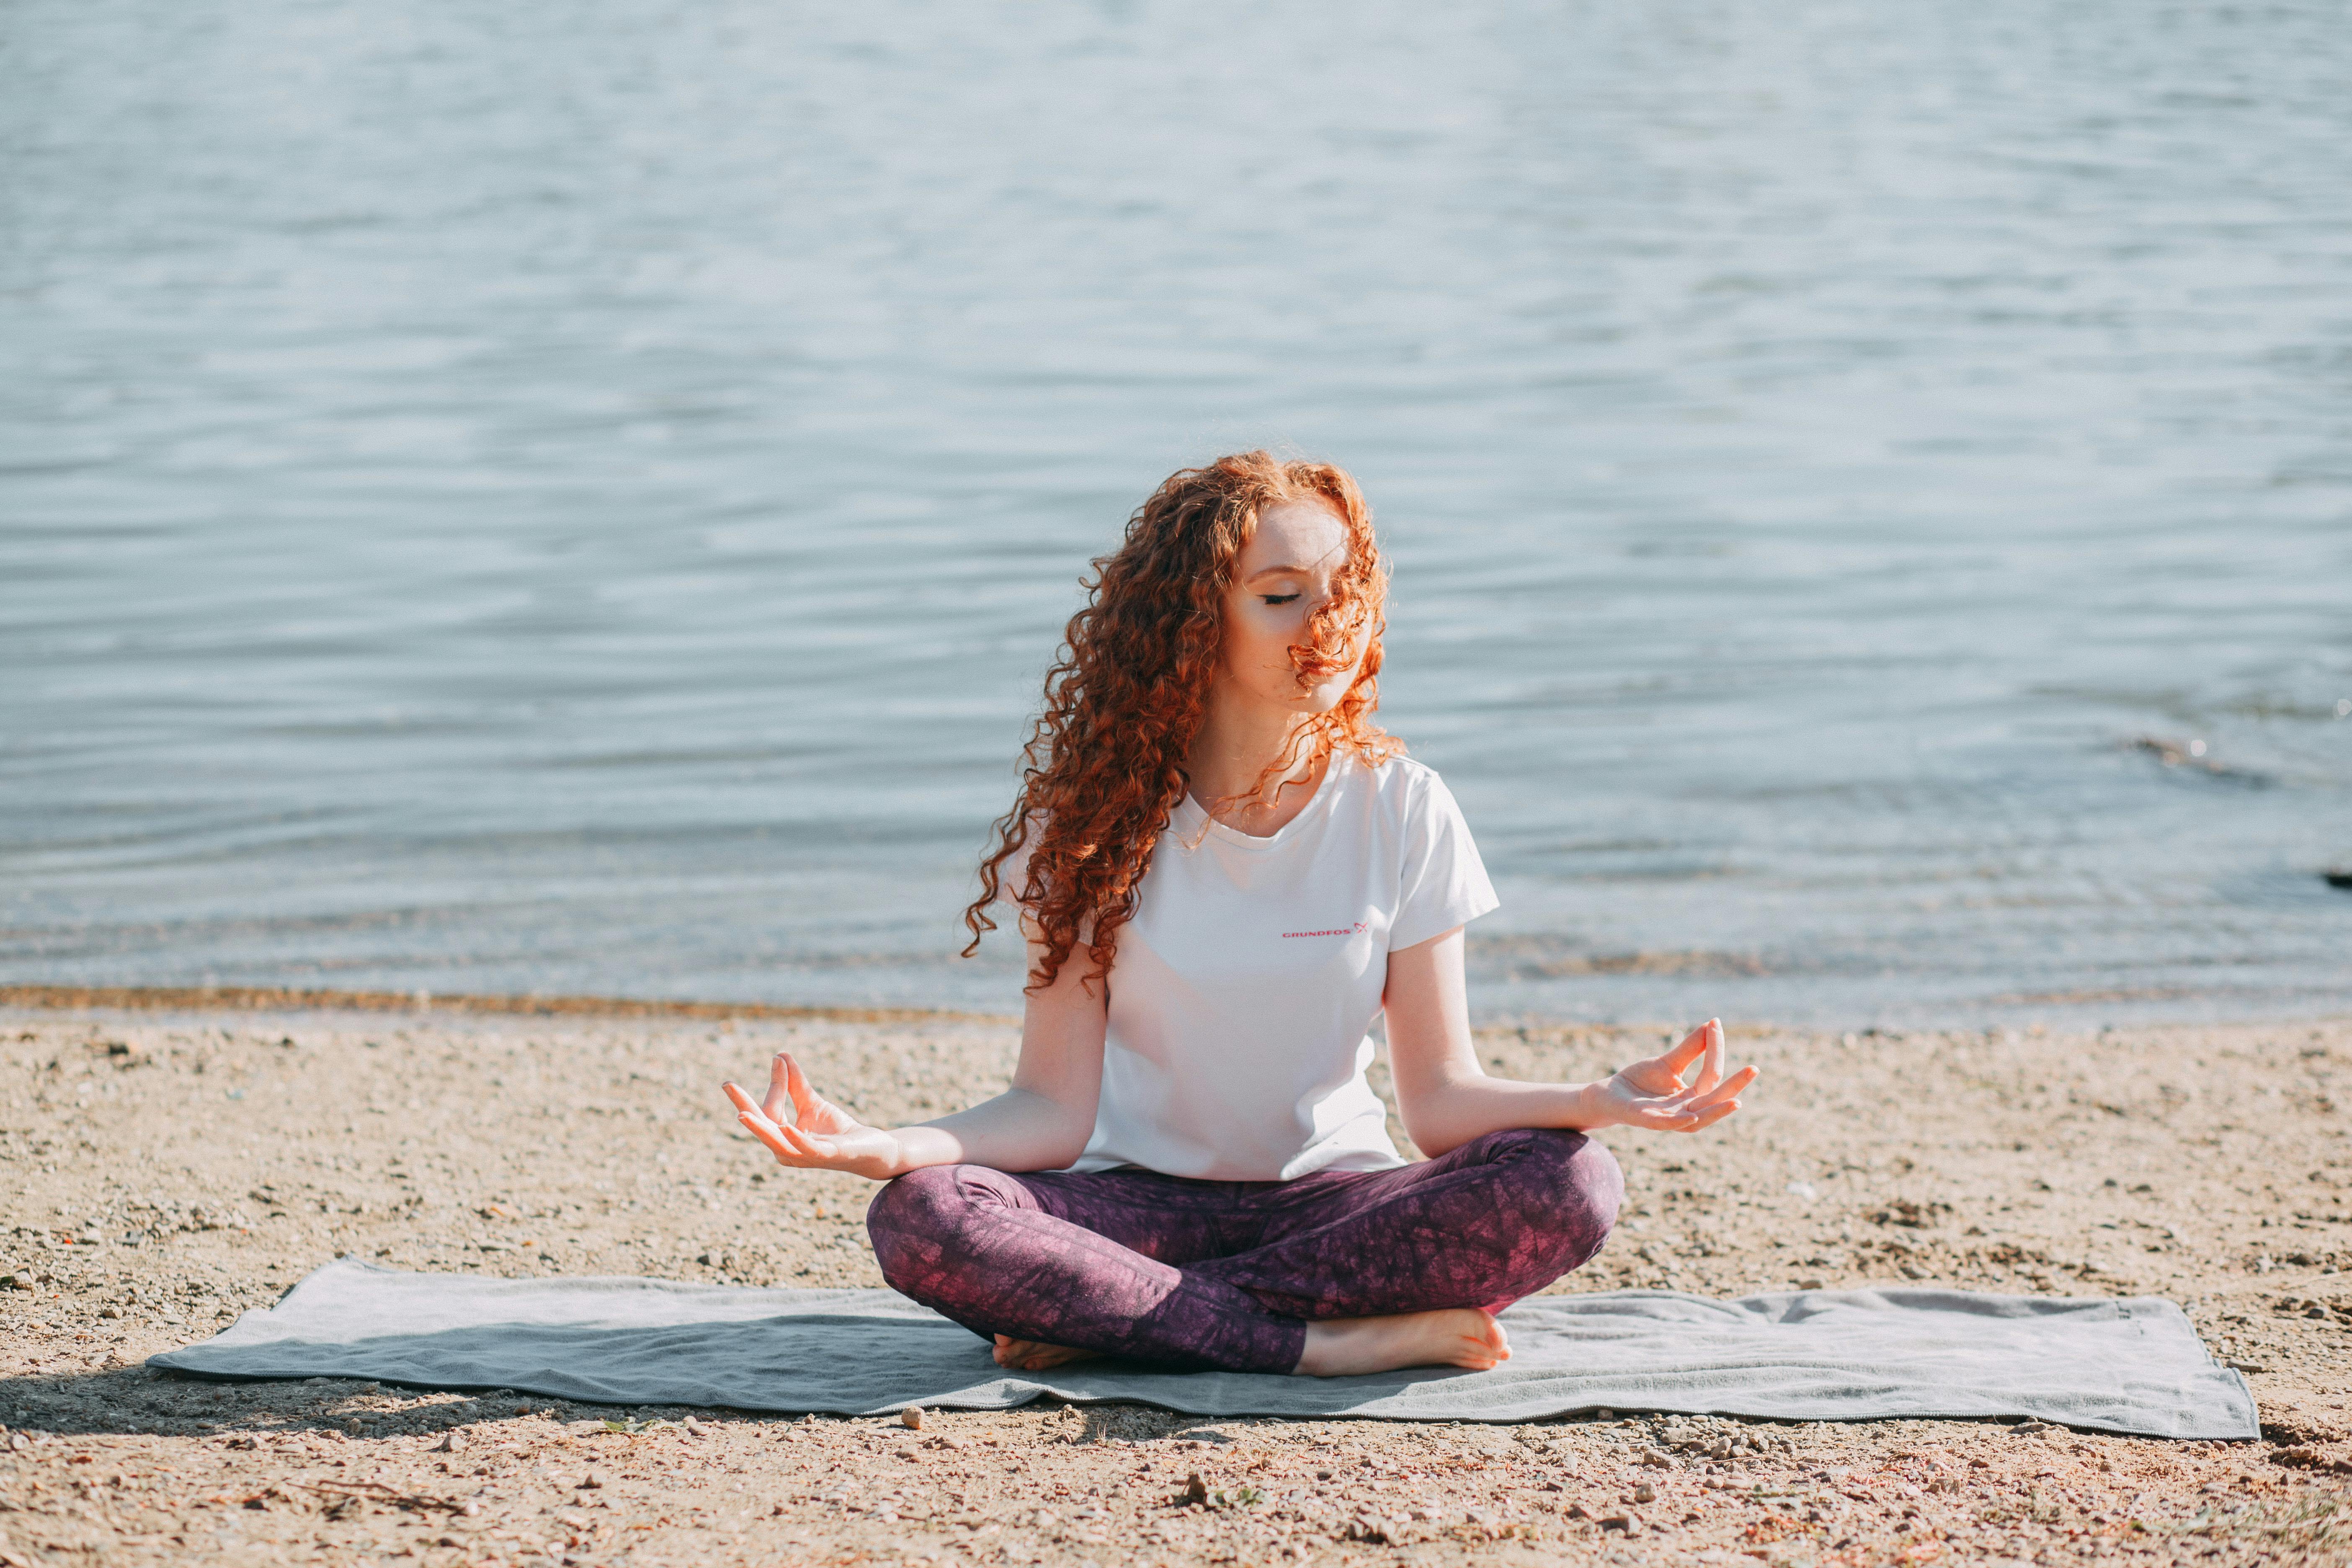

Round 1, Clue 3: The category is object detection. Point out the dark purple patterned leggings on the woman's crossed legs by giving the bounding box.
[866,1128,1625,1373]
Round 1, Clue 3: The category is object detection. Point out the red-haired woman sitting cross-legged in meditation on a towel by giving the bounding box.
[727,451,1755,1375]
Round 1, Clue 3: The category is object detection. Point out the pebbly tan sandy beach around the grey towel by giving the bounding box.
[0,1008,2352,1568]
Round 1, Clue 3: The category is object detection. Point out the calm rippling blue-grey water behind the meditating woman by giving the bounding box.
[0,0,2352,1025]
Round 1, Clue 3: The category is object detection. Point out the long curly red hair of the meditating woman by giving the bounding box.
[965,451,1404,990]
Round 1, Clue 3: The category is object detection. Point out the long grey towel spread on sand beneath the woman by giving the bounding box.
[150,1262,2258,1439]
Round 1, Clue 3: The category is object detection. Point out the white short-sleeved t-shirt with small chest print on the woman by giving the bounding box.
[1007,750,1501,1180]
